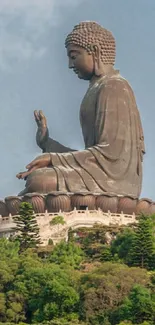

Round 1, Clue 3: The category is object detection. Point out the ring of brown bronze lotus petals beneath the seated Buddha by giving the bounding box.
[0,192,155,217]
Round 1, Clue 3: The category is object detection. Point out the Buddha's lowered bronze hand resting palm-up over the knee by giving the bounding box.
[16,153,51,179]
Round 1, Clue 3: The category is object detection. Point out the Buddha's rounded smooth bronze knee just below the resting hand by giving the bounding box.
[26,168,57,193]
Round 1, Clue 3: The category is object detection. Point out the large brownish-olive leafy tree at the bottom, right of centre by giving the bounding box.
[80,262,149,325]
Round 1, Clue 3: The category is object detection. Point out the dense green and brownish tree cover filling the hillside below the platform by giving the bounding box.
[0,214,155,325]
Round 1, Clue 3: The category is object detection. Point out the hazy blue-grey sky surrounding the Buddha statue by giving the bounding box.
[0,0,155,200]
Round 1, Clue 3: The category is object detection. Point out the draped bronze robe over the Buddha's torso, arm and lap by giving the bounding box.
[34,71,145,198]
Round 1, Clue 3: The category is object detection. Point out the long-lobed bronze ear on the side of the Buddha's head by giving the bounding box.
[91,44,104,77]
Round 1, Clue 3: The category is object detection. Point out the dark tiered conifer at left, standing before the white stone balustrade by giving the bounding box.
[14,202,41,252]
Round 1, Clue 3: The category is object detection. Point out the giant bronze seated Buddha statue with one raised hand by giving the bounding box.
[17,22,145,199]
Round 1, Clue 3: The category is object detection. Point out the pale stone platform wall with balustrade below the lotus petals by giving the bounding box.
[0,208,137,246]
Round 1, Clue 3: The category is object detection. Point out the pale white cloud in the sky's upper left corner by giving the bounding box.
[0,0,82,69]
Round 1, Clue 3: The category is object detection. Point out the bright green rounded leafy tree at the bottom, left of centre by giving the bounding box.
[14,260,79,323]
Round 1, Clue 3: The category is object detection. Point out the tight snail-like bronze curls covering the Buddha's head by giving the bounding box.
[65,21,116,65]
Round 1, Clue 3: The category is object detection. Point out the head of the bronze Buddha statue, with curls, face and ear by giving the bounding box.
[65,21,116,80]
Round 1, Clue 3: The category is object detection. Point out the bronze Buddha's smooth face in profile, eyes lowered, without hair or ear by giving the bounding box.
[67,44,94,80]
